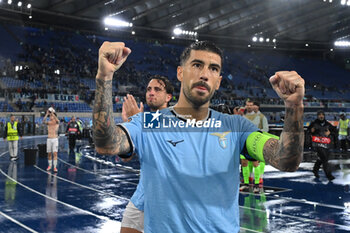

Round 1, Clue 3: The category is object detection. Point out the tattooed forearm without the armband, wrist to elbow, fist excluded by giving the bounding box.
[93,79,130,155]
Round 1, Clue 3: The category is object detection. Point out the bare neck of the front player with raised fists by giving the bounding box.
[174,93,209,120]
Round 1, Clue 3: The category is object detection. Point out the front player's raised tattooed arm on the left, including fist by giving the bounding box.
[93,42,131,155]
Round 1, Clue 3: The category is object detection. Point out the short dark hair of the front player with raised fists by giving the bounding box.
[180,40,224,68]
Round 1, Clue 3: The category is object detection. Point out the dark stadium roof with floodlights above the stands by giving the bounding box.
[0,0,350,50]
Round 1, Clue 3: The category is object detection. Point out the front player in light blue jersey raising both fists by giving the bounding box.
[93,41,305,233]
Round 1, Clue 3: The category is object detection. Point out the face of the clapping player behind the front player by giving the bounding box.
[146,79,171,111]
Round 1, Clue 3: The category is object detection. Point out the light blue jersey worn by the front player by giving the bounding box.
[123,109,258,233]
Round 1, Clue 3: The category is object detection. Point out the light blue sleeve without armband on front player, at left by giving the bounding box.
[118,113,143,159]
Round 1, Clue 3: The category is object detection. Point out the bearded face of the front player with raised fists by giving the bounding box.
[177,50,222,107]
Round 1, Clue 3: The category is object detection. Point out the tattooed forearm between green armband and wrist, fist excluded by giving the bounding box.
[263,106,304,171]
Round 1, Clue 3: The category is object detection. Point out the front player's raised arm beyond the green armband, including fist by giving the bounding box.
[263,71,305,171]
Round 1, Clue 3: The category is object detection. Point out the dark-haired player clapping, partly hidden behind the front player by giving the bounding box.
[120,75,174,233]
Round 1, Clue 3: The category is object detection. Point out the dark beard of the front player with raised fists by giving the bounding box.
[182,81,214,108]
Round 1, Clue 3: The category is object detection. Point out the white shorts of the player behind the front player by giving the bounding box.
[121,201,144,232]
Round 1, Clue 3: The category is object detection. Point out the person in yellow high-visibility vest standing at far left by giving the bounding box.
[4,115,23,161]
